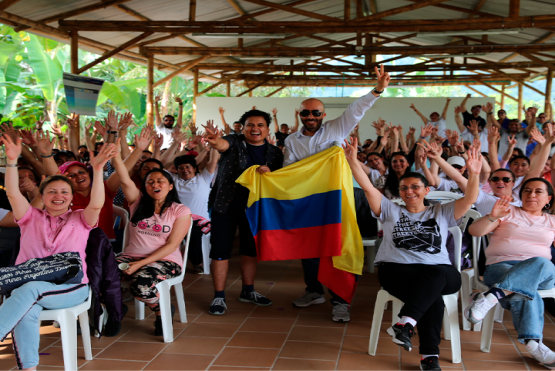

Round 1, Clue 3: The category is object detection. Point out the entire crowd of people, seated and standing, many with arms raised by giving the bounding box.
[0,66,555,371]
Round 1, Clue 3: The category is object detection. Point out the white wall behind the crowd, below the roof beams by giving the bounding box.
[197,97,497,140]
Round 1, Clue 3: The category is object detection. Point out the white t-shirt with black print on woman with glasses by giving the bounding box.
[372,197,458,265]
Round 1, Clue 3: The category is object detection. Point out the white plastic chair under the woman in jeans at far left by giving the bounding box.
[39,287,92,371]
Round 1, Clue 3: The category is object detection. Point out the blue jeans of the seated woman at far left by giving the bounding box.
[0,281,89,369]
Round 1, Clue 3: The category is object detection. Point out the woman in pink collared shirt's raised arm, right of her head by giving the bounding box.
[83,143,119,227]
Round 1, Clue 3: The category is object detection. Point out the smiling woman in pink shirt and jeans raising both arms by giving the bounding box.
[0,136,116,370]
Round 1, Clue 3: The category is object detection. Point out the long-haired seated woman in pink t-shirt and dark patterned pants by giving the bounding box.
[114,143,191,336]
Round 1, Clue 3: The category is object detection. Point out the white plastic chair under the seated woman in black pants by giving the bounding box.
[368,227,462,363]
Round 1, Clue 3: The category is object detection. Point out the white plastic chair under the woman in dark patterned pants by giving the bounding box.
[135,218,193,343]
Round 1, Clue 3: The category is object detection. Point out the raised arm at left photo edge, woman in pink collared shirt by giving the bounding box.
[0,135,30,220]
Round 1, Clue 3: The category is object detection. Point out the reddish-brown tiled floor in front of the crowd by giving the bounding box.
[0,257,555,371]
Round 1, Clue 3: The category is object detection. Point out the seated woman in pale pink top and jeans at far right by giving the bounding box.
[465,178,555,369]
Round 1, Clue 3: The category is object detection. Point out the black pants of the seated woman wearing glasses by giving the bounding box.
[378,263,461,354]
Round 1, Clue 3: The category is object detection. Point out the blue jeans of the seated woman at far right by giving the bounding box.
[484,258,555,343]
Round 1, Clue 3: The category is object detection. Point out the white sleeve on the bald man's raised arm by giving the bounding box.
[322,92,379,141]
